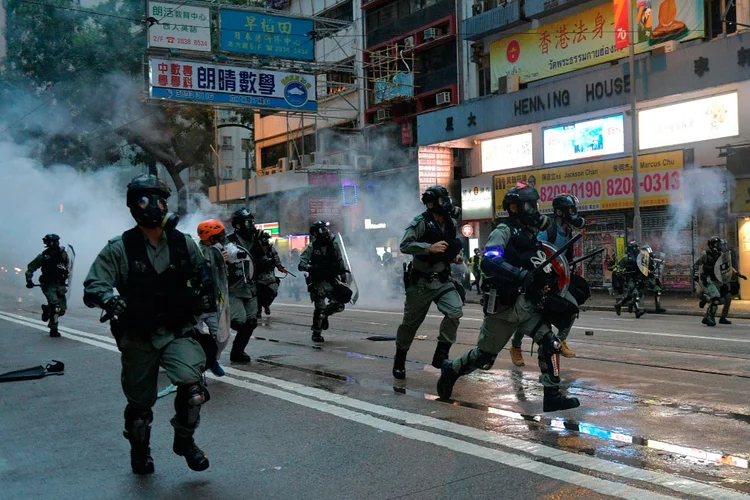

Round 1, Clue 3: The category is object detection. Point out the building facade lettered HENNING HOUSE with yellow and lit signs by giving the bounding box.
[418,0,750,296]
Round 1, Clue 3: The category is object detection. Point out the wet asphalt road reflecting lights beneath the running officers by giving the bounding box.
[0,280,750,499]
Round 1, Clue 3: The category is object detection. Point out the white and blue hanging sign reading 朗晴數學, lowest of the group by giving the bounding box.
[149,59,318,111]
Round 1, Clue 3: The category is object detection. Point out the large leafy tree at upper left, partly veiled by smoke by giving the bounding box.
[0,0,252,213]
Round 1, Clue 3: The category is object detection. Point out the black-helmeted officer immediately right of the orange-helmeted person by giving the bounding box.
[227,208,258,363]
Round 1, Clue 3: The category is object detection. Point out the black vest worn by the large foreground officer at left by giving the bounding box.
[120,228,201,332]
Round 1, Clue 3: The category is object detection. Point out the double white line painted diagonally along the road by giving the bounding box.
[0,312,748,500]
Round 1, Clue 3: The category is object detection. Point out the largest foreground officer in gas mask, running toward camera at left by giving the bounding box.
[83,175,209,474]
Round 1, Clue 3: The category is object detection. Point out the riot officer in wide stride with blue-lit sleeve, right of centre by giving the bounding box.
[437,182,580,411]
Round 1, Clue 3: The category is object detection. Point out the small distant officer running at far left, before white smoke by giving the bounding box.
[26,234,70,337]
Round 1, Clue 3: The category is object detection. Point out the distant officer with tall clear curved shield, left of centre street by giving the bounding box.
[298,220,351,342]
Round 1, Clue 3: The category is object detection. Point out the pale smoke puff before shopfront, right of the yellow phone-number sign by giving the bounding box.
[663,168,730,258]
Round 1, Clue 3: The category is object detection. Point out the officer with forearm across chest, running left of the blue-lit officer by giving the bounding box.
[393,186,463,379]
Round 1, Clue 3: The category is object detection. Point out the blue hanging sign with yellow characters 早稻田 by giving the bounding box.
[219,9,315,61]
